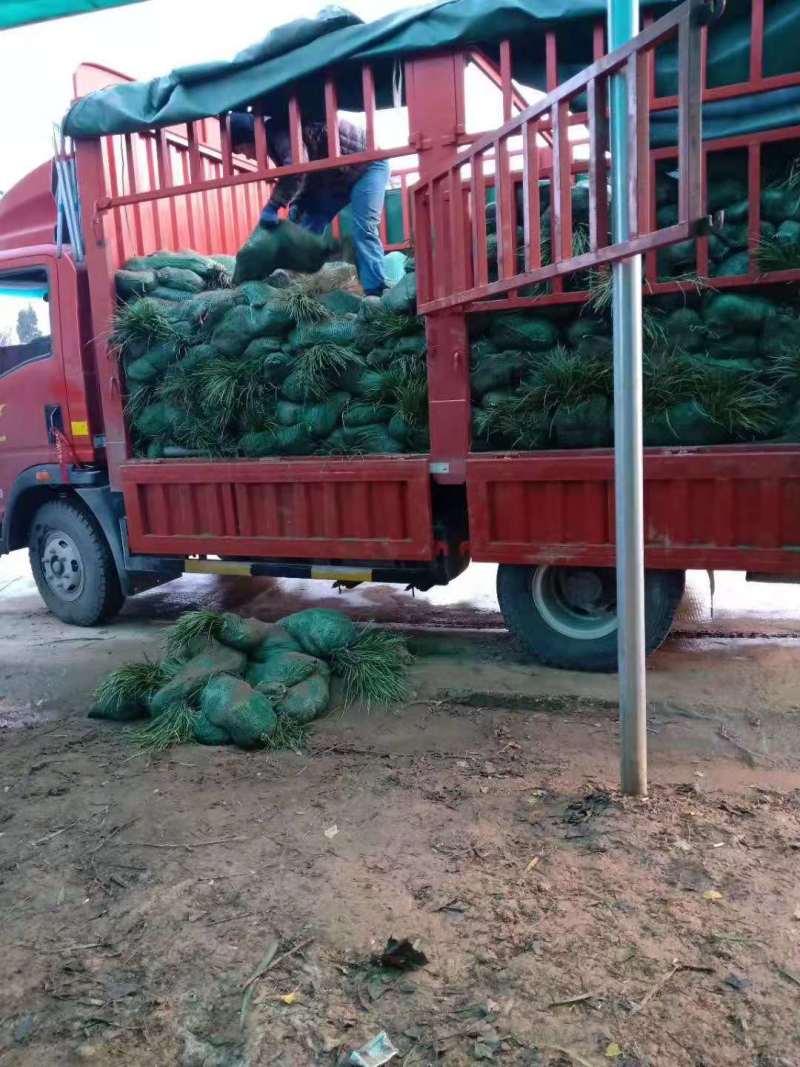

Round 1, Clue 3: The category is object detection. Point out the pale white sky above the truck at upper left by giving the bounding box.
[0,0,426,192]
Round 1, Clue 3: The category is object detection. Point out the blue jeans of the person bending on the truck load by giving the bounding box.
[291,159,389,290]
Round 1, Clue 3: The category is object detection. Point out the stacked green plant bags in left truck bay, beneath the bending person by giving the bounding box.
[112,222,428,458]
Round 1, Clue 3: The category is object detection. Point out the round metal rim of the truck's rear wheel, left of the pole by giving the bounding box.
[531,567,618,641]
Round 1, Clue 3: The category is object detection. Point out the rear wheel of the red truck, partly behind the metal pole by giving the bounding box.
[497,563,685,672]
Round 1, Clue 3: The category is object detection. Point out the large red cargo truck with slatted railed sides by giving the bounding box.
[0,0,800,670]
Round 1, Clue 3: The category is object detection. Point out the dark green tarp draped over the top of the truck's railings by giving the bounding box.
[65,0,800,143]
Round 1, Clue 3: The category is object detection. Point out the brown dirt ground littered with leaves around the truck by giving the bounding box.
[0,560,800,1067]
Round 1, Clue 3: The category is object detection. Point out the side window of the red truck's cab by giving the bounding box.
[0,268,52,378]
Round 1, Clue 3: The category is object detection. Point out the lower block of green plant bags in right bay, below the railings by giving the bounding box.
[471,281,800,450]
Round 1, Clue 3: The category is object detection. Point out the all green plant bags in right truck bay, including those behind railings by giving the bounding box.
[471,144,800,450]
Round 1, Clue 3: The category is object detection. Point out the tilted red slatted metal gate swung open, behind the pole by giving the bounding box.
[414,0,709,314]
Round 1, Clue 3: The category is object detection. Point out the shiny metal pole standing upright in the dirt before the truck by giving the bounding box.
[608,0,647,796]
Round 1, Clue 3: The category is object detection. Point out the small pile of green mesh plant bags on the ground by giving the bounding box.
[90,609,411,748]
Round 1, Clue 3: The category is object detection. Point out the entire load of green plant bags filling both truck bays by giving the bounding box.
[113,141,800,458]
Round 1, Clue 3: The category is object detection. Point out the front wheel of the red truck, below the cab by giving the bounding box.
[28,500,125,626]
